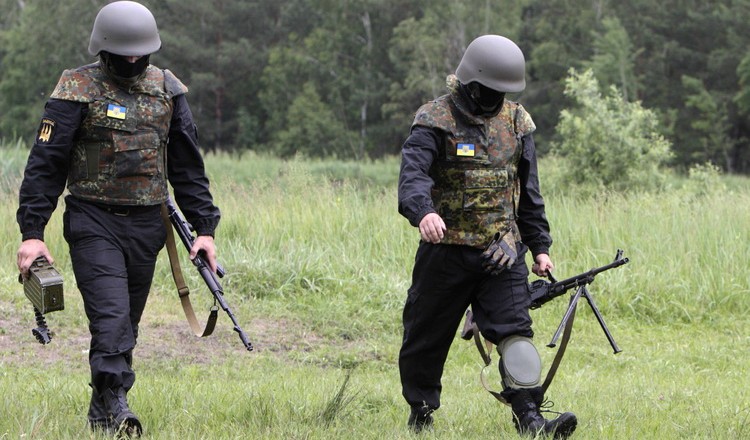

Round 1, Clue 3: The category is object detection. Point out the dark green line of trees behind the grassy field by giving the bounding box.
[0,0,750,174]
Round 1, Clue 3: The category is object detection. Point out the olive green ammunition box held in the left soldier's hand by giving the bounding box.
[18,257,65,345]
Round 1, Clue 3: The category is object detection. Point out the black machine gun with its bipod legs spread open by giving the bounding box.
[529,249,630,354]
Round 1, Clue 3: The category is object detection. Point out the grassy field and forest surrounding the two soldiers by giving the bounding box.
[0,0,750,440]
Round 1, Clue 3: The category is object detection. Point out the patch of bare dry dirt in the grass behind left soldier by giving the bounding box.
[0,298,314,369]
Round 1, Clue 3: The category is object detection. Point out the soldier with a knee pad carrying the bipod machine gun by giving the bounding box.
[398,35,577,438]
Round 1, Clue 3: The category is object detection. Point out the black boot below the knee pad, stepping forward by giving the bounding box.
[502,387,578,439]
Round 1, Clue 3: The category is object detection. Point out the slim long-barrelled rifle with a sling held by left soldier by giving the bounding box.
[165,199,253,351]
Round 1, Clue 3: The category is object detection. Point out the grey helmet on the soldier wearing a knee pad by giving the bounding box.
[456,35,526,93]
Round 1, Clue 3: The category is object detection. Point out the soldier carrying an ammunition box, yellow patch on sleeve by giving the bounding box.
[17,1,220,436]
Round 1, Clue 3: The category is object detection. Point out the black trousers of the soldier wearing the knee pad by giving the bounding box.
[399,242,533,409]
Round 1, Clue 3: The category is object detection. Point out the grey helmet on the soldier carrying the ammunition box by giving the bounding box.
[89,1,161,57]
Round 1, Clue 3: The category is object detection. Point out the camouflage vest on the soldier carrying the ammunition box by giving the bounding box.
[51,63,187,205]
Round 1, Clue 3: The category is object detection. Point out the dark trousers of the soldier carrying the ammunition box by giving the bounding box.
[63,196,166,393]
